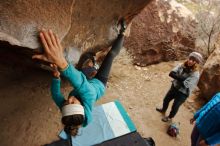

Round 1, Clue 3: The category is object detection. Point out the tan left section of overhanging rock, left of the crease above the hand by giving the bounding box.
[0,0,73,49]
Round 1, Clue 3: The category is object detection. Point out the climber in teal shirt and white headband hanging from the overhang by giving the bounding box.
[32,20,126,136]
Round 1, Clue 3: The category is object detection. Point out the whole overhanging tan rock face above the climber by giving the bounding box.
[0,0,150,64]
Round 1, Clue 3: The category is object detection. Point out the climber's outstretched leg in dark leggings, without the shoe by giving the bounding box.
[95,34,124,85]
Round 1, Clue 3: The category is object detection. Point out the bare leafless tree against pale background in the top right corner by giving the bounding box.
[196,0,220,56]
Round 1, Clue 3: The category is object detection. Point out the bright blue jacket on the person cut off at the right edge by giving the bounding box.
[194,93,220,145]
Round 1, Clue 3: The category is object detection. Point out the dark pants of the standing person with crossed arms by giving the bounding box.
[162,85,187,118]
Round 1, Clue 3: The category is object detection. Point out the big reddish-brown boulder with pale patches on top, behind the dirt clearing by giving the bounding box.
[125,0,195,66]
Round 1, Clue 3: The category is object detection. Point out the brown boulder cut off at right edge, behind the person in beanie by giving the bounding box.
[198,46,220,99]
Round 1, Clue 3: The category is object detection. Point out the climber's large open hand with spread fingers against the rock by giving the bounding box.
[32,30,68,69]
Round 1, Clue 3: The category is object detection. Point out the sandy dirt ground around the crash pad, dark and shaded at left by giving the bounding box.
[0,49,203,146]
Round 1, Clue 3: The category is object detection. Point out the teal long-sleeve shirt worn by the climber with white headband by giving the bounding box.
[51,64,105,127]
